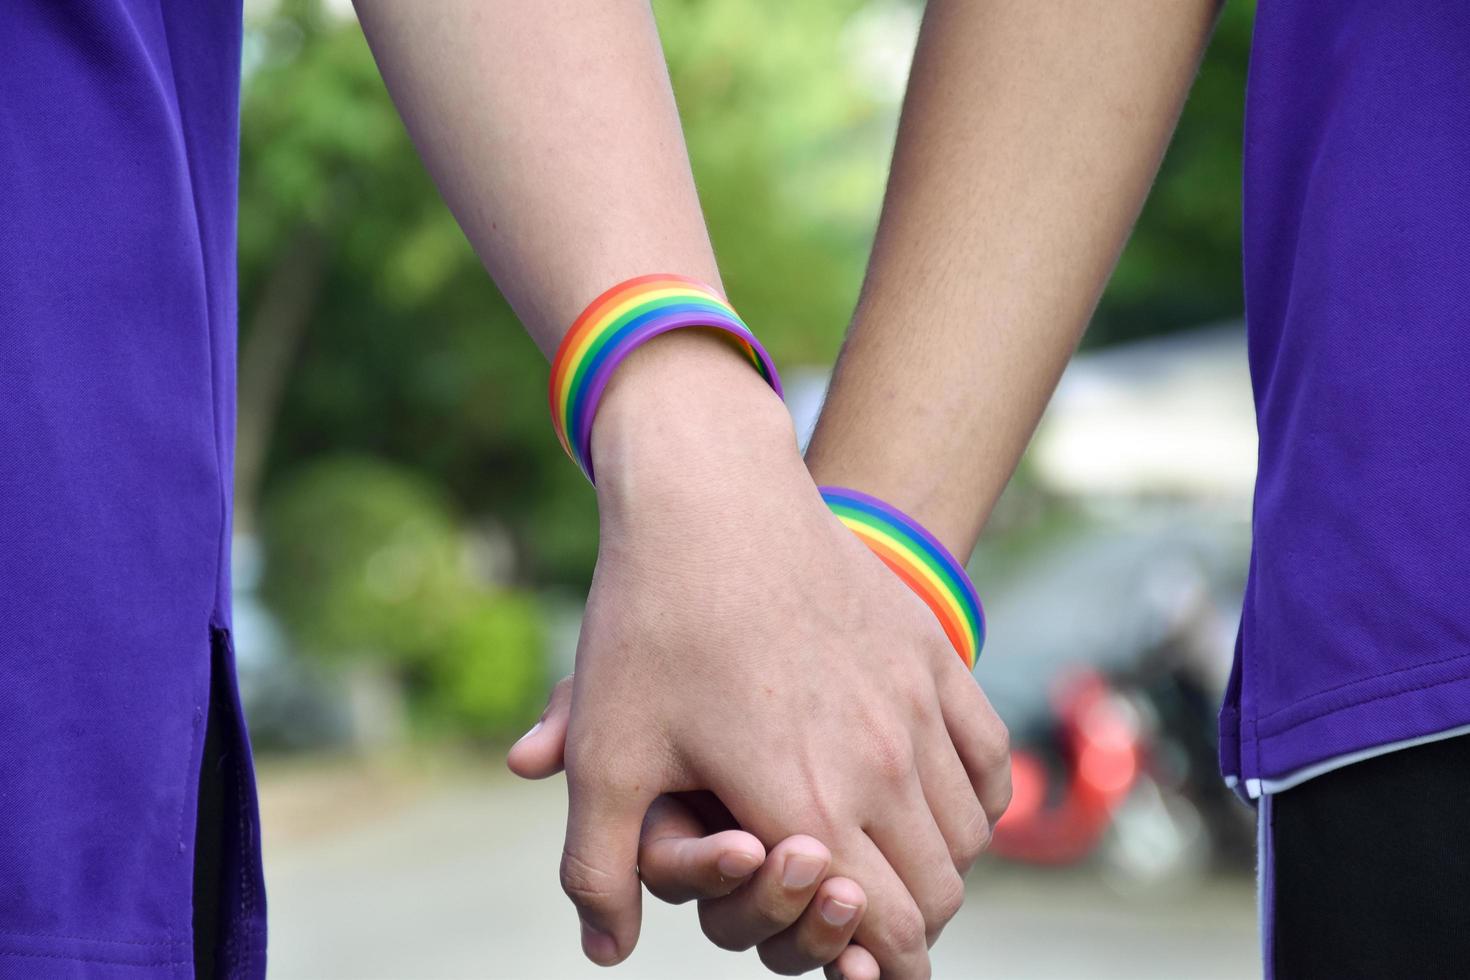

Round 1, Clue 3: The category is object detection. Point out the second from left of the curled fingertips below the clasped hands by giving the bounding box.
[700,835,832,951]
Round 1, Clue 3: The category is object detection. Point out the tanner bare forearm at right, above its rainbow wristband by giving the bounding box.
[807,0,1216,555]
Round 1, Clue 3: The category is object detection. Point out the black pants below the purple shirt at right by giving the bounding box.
[1270,736,1470,980]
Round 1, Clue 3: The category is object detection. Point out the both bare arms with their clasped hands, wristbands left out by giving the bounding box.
[356,0,1219,980]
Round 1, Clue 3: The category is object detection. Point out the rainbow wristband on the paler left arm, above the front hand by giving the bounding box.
[550,275,781,483]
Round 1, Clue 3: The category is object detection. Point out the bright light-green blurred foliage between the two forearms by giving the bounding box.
[654,0,894,363]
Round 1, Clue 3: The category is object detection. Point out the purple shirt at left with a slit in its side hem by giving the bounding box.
[0,0,265,979]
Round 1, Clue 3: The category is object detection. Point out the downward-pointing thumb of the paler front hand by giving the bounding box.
[562,764,657,967]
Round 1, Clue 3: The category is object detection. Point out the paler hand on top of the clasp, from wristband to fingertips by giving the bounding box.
[511,331,1010,980]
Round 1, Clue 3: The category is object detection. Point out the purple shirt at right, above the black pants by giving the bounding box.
[1220,0,1470,795]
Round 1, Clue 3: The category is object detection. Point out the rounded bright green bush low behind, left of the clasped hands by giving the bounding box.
[263,457,547,738]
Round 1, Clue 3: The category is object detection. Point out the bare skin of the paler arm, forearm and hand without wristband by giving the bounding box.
[357,0,1008,977]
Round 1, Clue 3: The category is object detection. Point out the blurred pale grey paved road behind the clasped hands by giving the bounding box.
[262,765,1258,980]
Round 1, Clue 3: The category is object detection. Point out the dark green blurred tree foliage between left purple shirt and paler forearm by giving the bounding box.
[240,3,597,582]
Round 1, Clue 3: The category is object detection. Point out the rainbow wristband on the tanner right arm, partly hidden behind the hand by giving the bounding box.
[817,486,985,670]
